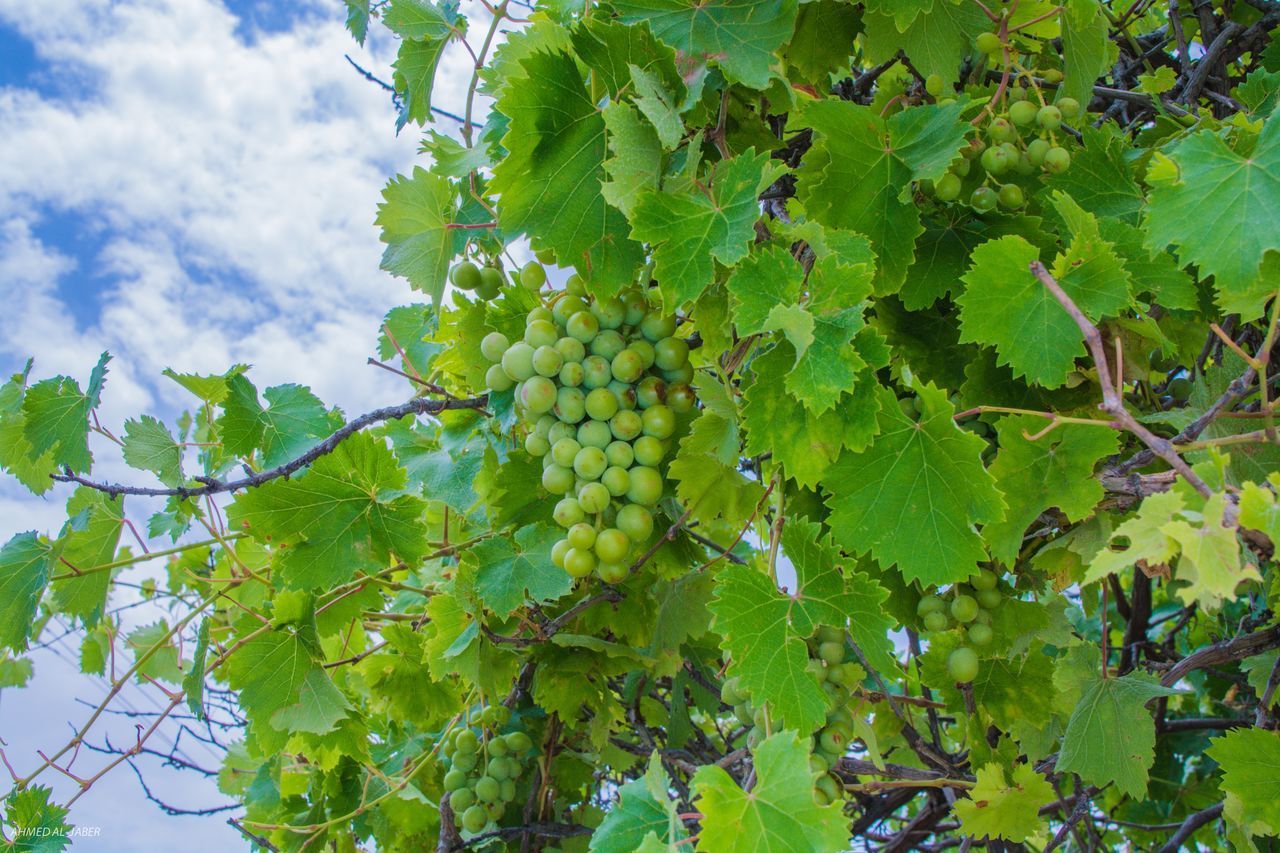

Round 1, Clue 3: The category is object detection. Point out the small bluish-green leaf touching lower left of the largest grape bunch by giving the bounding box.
[471,524,573,619]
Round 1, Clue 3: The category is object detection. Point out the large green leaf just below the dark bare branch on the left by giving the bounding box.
[228,433,428,589]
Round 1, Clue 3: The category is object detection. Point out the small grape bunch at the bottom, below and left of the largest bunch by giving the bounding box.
[440,706,534,833]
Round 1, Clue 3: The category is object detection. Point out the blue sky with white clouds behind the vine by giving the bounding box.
[0,0,483,850]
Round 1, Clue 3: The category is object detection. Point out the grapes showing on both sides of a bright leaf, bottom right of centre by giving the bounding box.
[721,625,865,806]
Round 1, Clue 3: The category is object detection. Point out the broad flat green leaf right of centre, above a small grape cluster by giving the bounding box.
[823,384,1005,584]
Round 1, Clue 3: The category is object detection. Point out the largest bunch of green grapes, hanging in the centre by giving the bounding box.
[480,273,696,584]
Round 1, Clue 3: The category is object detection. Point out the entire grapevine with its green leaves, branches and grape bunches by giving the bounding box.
[0,0,1280,853]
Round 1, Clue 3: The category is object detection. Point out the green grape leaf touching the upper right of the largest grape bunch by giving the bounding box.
[631,150,777,310]
